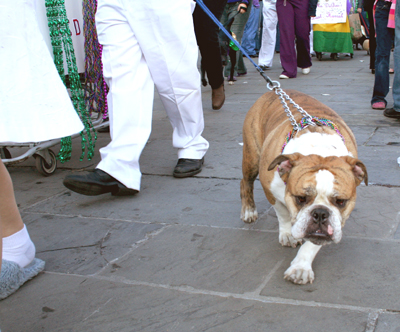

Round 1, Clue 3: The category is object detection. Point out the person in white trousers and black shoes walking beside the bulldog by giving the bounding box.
[64,0,209,195]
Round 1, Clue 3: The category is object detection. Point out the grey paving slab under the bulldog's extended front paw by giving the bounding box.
[261,237,400,311]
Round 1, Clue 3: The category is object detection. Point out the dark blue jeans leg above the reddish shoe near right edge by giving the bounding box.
[371,0,394,105]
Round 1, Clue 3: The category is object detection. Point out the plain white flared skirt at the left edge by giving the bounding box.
[0,0,83,143]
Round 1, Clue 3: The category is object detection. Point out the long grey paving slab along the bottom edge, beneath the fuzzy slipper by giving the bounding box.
[0,274,368,332]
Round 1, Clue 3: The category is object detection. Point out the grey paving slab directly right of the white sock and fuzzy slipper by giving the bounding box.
[23,214,162,275]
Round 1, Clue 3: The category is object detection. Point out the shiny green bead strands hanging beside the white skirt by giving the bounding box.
[45,0,97,163]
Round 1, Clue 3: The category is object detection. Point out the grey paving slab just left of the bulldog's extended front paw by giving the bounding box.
[101,226,287,294]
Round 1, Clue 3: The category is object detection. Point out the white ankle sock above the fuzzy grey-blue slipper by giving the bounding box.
[3,225,36,267]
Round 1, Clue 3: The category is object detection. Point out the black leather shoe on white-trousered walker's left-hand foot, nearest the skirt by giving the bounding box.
[63,168,139,196]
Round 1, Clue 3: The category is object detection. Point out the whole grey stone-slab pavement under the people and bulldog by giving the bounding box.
[0,51,400,332]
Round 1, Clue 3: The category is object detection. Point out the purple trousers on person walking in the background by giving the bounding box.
[276,0,312,78]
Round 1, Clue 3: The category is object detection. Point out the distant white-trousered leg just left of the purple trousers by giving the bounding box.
[258,0,278,70]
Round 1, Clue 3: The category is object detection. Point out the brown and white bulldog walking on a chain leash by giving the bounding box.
[240,90,368,284]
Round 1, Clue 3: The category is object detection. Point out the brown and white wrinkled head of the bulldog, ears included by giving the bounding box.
[270,153,368,245]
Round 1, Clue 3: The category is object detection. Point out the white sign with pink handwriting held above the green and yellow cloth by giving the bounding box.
[311,0,347,24]
